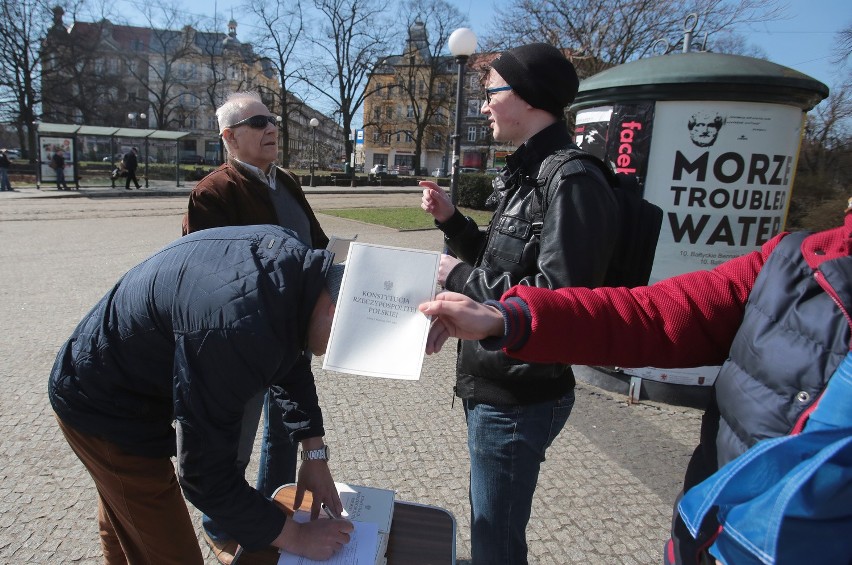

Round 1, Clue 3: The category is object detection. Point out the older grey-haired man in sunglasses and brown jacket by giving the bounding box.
[183,92,328,565]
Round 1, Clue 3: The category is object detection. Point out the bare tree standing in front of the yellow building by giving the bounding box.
[382,0,465,174]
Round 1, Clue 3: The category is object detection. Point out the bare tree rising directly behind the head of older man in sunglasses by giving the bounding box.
[248,0,304,167]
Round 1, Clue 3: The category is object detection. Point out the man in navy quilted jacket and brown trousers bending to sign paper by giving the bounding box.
[49,226,352,565]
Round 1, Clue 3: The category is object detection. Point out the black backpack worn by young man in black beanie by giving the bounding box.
[535,149,663,288]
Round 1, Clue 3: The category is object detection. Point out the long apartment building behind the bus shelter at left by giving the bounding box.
[42,7,344,166]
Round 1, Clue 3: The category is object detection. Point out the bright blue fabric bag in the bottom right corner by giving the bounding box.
[678,354,852,565]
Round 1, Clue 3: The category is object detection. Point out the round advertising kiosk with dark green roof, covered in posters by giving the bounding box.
[570,52,828,405]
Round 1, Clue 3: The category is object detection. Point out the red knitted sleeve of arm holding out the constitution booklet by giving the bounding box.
[502,234,785,367]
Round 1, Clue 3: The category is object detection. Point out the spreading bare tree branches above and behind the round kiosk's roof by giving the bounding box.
[485,0,782,74]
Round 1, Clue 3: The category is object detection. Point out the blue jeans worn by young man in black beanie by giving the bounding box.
[464,391,574,565]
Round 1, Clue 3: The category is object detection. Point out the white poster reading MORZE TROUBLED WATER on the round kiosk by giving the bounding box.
[644,101,803,282]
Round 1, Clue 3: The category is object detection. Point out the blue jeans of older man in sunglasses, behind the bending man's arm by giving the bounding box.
[201,390,298,542]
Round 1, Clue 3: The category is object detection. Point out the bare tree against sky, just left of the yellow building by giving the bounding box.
[304,0,388,165]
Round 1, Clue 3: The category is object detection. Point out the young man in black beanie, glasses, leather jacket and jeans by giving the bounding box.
[420,43,618,565]
